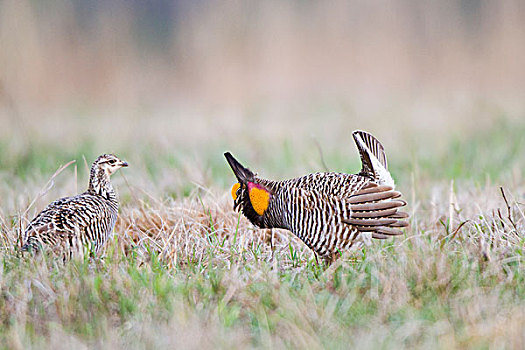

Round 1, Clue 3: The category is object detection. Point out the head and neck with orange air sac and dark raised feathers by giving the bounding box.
[224,152,273,227]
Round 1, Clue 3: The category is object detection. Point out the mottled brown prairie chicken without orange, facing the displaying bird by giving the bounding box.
[22,154,128,259]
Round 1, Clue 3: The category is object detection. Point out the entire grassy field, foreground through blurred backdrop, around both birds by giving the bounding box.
[0,0,525,349]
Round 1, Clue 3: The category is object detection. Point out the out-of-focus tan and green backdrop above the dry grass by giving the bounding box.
[0,0,525,197]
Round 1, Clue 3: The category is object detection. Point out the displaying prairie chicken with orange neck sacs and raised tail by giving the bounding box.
[224,131,408,261]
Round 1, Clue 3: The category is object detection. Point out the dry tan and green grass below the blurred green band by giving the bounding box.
[0,121,525,348]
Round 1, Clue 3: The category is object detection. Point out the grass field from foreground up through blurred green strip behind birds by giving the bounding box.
[0,113,525,349]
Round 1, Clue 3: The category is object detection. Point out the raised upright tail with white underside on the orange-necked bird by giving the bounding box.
[352,130,395,187]
